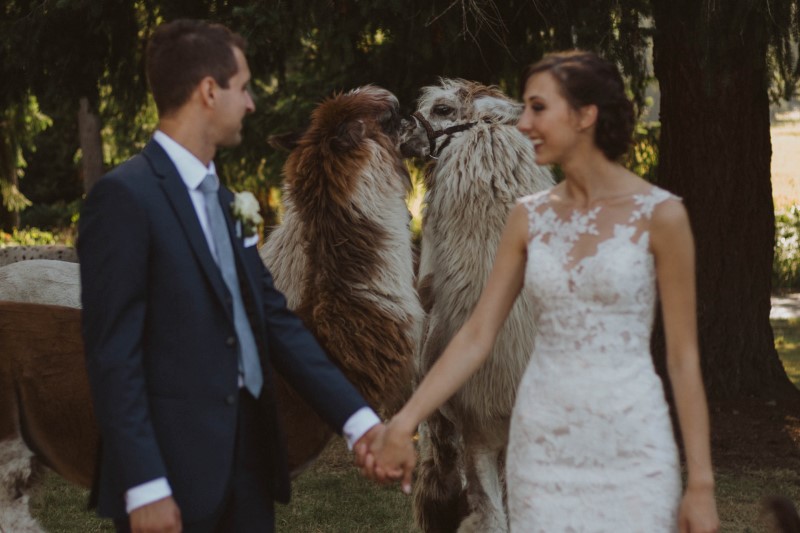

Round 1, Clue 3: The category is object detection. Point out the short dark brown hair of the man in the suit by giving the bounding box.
[146,19,247,117]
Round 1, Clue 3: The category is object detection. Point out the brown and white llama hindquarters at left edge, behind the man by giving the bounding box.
[0,259,91,532]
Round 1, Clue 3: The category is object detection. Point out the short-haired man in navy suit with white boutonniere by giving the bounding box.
[78,20,404,532]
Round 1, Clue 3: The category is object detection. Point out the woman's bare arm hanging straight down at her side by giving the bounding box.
[651,201,719,533]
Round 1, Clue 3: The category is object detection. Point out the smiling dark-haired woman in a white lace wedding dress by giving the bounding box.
[361,52,719,533]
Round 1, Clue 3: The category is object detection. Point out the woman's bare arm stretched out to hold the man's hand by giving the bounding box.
[371,204,528,488]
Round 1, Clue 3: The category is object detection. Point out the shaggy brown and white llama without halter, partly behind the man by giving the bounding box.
[0,87,422,531]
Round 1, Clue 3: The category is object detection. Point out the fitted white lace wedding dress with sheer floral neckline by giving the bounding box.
[506,187,681,533]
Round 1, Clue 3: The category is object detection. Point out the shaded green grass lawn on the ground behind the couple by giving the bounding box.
[26,319,800,533]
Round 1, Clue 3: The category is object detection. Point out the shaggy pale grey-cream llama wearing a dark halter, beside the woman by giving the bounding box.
[401,79,553,532]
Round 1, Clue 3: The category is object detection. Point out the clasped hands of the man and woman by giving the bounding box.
[353,420,417,494]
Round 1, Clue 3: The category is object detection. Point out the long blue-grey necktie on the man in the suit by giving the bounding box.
[198,174,264,398]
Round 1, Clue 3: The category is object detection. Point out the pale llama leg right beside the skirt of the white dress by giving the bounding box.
[458,443,508,533]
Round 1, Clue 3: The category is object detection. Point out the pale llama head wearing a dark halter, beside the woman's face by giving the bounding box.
[400,78,522,157]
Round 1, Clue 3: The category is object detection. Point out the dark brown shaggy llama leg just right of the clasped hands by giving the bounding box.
[413,411,465,533]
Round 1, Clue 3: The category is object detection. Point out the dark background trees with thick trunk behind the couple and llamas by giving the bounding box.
[0,0,800,396]
